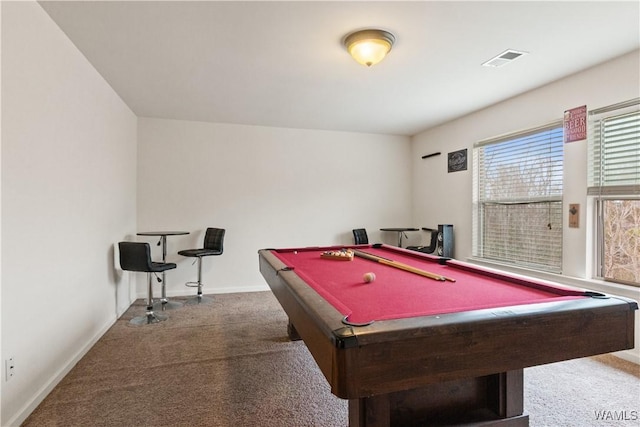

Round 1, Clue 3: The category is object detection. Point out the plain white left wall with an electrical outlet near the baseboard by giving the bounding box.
[0,2,137,426]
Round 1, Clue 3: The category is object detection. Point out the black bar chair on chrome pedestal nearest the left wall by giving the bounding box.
[118,242,176,325]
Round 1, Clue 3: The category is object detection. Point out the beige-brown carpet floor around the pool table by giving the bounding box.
[23,292,640,427]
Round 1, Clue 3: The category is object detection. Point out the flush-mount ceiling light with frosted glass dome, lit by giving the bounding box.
[344,29,396,67]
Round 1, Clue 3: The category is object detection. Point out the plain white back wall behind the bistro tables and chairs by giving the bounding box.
[138,118,412,296]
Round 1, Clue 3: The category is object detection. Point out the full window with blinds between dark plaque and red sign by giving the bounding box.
[473,122,563,272]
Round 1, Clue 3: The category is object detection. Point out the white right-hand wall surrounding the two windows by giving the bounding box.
[411,51,640,363]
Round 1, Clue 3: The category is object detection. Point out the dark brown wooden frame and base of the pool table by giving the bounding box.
[258,248,638,427]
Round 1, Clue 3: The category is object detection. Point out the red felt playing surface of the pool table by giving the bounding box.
[274,245,584,323]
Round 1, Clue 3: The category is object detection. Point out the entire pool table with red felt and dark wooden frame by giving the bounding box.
[258,244,638,427]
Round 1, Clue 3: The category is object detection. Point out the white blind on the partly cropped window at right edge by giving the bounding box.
[588,99,640,195]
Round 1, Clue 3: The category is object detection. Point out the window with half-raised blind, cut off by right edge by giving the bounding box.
[587,99,640,286]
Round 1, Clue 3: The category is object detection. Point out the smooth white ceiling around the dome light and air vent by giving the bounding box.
[40,0,640,135]
